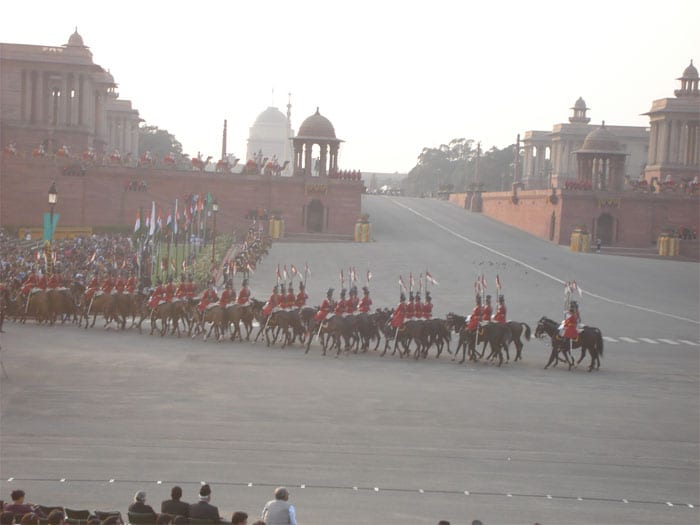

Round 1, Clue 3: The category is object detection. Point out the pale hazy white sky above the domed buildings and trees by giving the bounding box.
[0,0,700,172]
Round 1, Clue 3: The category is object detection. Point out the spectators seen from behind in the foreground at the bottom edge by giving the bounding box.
[0,484,297,525]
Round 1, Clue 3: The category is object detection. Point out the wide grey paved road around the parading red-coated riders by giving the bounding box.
[0,197,700,525]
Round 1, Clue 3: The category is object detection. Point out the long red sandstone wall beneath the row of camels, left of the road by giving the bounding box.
[0,158,362,235]
